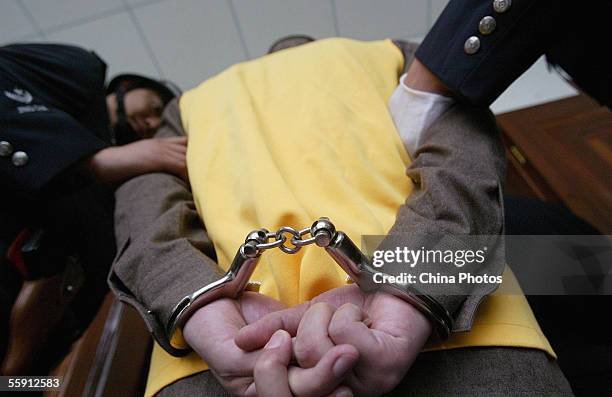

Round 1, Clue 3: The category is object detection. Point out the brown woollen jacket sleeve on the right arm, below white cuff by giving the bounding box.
[384,41,506,332]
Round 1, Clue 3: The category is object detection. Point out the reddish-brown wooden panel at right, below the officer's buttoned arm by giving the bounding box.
[497,96,612,234]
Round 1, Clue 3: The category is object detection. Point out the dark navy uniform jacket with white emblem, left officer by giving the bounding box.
[0,44,111,197]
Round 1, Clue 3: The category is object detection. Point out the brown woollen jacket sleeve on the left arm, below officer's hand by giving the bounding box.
[109,100,224,355]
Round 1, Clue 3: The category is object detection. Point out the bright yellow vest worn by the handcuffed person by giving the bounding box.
[146,39,554,396]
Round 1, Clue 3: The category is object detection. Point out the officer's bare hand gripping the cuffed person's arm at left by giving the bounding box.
[87,137,187,184]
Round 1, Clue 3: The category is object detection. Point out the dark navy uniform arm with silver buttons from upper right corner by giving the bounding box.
[416,0,612,107]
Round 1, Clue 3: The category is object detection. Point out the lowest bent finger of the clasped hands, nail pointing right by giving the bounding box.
[289,345,359,397]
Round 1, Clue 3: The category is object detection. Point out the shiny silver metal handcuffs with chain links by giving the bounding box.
[166,217,453,350]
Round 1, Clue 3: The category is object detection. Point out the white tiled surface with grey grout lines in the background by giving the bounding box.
[0,0,574,112]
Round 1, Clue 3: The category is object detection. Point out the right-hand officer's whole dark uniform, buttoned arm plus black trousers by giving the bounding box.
[416,0,612,395]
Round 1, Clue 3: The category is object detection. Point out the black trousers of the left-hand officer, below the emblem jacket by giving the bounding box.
[0,184,116,366]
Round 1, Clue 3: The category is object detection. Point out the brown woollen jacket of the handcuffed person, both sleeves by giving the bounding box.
[109,42,505,355]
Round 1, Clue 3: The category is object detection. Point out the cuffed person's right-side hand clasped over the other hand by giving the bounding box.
[236,285,431,396]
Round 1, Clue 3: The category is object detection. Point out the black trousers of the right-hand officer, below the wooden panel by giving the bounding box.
[504,197,612,396]
